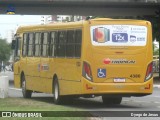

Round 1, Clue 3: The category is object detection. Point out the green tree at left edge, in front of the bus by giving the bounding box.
[0,38,11,62]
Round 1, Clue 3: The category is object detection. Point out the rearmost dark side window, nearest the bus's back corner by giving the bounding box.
[75,29,82,58]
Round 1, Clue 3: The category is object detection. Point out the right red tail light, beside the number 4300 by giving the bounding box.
[145,62,153,81]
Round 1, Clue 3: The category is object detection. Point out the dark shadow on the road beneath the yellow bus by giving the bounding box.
[31,97,142,110]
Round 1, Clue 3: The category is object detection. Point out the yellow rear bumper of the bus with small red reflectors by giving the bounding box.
[82,78,153,96]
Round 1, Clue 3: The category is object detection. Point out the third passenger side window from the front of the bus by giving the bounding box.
[34,33,40,57]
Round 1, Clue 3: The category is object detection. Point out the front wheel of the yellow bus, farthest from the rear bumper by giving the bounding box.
[22,75,32,98]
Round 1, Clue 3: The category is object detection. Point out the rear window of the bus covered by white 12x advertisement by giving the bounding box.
[90,25,147,46]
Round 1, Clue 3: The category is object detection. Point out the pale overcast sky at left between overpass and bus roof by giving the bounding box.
[0,15,43,38]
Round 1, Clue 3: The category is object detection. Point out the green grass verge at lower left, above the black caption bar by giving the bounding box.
[0,98,73,111]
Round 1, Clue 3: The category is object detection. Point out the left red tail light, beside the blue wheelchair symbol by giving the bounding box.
[82,62,92,81]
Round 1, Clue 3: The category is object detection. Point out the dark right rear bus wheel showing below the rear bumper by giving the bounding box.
[102,96,122,105]
